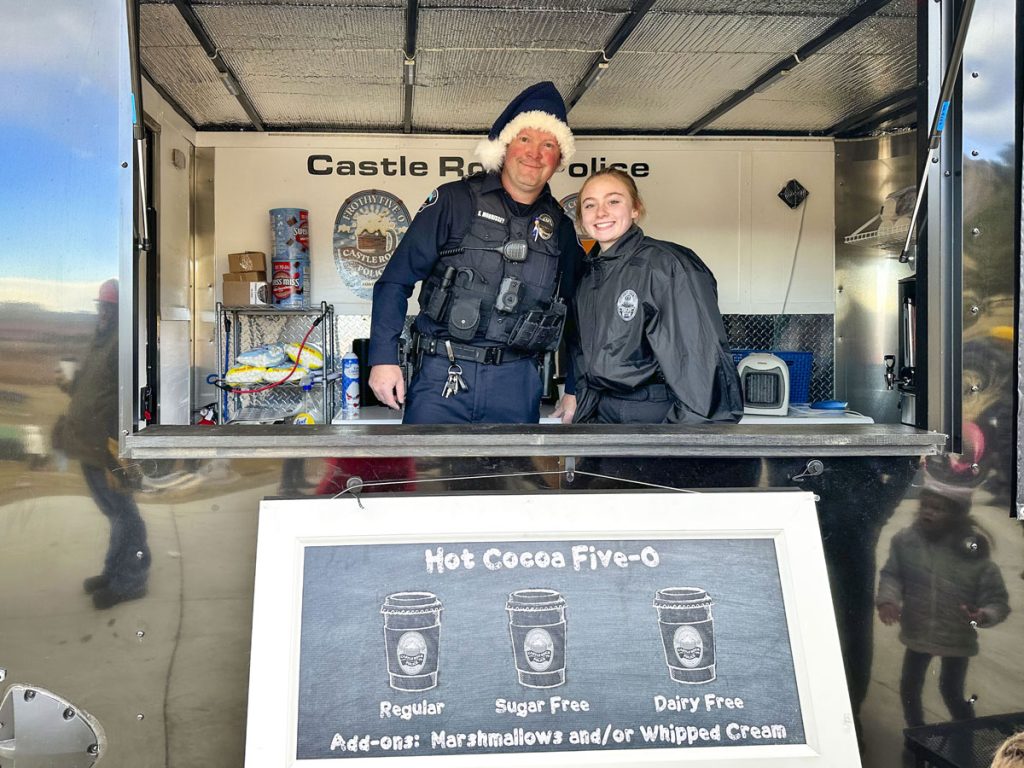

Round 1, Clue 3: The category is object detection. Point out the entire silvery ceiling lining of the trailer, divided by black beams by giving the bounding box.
[140,0,918,134]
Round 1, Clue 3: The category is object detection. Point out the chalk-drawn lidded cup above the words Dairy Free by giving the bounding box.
[654,587,716,684]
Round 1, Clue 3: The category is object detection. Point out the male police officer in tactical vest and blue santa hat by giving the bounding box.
[369,82,583,424]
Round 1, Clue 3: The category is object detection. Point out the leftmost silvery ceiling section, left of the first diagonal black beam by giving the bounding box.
[139,3,250,127]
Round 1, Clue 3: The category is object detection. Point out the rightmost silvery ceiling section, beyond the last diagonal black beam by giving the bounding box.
[708,16,916,131]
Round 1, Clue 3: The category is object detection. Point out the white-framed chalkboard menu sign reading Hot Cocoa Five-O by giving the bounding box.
[246,493,858,766]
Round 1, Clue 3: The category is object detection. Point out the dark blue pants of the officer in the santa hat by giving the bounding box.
[401,355,541,424]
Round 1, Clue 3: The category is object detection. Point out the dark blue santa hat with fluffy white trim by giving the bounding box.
[475,80,575,171]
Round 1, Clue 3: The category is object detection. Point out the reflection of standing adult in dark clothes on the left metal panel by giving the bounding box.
[57,280,151,609]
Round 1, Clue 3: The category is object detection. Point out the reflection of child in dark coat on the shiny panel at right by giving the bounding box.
[874,474,1010,727]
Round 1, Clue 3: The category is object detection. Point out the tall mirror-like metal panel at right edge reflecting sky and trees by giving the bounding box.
[961,0,1021,509]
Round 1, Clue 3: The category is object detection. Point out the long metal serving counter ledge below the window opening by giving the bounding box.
[124,421,945,459]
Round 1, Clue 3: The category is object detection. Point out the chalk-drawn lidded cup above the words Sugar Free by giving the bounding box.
[505,589,565,688]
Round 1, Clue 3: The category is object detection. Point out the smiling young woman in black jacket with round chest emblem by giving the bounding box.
[561,169,743,424]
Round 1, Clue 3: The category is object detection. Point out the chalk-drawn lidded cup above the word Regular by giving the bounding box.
[381,592,442,691]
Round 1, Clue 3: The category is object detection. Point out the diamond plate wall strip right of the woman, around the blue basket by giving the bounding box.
[723,314,836,402]
